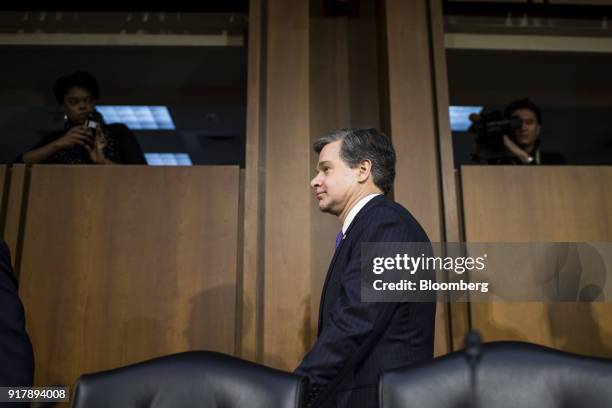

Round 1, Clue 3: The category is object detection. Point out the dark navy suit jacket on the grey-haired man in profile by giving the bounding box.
[296,195,436,408]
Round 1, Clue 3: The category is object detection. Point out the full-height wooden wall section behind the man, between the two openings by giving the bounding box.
[241,0,448,369]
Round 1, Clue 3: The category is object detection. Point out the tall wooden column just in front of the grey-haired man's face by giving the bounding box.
[243,0,312,370]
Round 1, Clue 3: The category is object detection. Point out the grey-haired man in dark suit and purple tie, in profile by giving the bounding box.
[296,129,436,408]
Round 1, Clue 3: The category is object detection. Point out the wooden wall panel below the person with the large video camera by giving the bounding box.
[461,166,612,357]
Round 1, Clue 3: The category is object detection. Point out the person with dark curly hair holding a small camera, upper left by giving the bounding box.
[15,71,146,164]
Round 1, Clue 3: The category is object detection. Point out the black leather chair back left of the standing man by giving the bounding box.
[71,351,303,408]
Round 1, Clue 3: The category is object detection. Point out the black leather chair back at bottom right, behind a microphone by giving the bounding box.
[379,342,612,408]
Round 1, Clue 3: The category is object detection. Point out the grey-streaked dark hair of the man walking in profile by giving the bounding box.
[313,128,395,194]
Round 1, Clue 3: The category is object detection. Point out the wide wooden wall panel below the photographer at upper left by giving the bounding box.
[20,166,238,385]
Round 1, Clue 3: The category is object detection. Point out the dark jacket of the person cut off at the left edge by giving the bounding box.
[0,239,34,388]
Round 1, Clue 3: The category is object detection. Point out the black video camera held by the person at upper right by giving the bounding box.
[468,109,523,163]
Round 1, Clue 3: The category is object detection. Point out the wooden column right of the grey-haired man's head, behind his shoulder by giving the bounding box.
[384,0,458,355]
